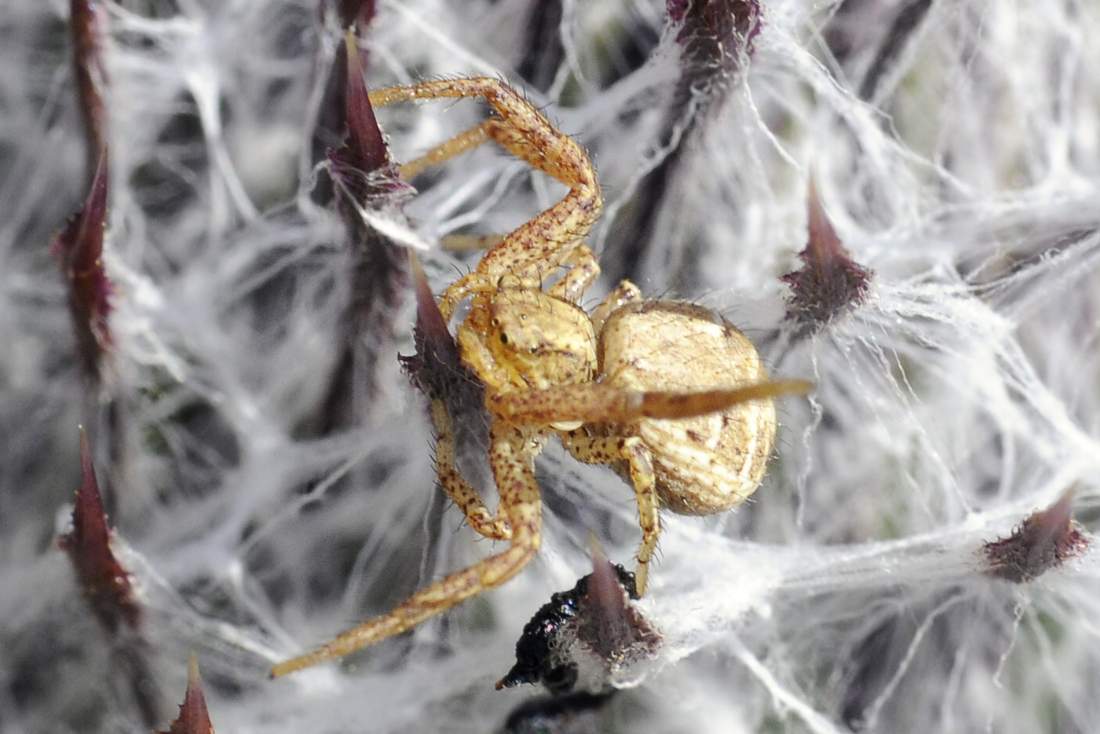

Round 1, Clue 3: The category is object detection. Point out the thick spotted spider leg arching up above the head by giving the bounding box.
[370,77,603,320]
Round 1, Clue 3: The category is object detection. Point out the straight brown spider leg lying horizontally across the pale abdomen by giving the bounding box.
[485,380,811,426]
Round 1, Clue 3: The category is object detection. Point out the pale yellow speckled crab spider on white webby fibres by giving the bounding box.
[272,77,807,676]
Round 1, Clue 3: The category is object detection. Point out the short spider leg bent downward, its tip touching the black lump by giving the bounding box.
[562,429,661,596]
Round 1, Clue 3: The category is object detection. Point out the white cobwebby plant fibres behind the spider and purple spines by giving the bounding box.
[0,0,1100,734]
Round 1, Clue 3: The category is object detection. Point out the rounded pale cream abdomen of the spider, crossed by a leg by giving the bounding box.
[598,300,776,515]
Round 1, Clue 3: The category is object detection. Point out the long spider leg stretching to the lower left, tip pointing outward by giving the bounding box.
[271,427,542,678]
